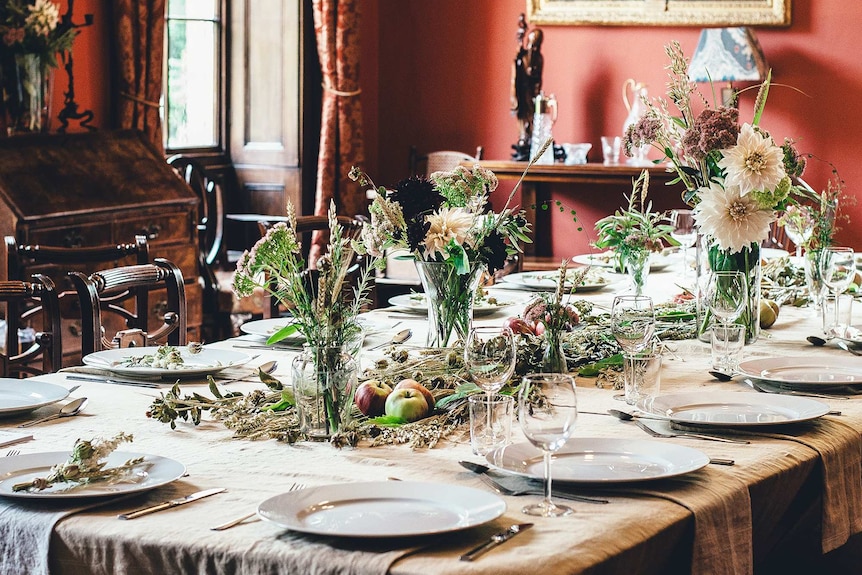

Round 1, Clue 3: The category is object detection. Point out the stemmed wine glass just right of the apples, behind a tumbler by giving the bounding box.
[464,326,517,448]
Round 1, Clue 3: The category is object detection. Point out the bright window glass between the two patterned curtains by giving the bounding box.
[162,0,222,151]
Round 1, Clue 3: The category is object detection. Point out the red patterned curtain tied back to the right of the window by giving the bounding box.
[309,0,365,261]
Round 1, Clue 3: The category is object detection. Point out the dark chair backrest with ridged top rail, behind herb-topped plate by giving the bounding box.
[69,258,188,355]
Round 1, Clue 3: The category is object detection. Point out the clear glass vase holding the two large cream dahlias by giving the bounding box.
[697,243,762,344]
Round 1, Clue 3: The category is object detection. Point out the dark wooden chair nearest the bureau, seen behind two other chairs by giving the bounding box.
[5,235,150,369]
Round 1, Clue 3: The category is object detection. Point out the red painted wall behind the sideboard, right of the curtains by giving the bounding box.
[362,0,862,256]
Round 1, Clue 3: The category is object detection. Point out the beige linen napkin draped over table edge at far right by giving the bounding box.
[674,418,862,553]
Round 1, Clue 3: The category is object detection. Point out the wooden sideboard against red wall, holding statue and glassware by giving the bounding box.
[470,160,684,269]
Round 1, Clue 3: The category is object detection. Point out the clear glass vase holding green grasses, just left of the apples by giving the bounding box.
[291,344,359,440]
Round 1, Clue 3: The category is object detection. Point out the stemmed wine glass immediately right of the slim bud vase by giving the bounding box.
[611,295,655,405]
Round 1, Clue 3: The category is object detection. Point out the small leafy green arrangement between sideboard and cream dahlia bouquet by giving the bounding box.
[594,170,678,271]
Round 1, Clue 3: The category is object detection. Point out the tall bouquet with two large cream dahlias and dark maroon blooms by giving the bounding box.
[625,42,832,343]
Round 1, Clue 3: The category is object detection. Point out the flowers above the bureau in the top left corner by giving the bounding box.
[0,0,77,68]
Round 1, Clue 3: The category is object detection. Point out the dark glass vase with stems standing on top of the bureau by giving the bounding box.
[3,54,53,136]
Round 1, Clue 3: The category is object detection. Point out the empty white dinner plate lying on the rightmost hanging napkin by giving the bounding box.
[639,391,829,427]
